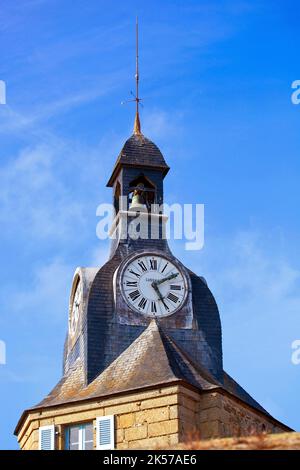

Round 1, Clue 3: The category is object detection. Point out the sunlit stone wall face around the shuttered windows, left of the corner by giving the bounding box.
[18,386,179,450]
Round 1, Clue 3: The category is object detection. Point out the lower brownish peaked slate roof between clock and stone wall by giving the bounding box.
[26,320,267,413]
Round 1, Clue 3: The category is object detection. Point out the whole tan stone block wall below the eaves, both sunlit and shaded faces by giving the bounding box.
[18,385,287,450]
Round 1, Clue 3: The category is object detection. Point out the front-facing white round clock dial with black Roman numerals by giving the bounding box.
[120,254,187,317]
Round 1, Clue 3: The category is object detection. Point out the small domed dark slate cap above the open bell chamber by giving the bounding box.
[107,134,170,186]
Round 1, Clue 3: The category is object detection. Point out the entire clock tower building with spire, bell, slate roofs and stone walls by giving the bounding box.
[15,21,290,450]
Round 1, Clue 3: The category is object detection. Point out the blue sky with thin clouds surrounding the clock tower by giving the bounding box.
[0,0,300,449]
